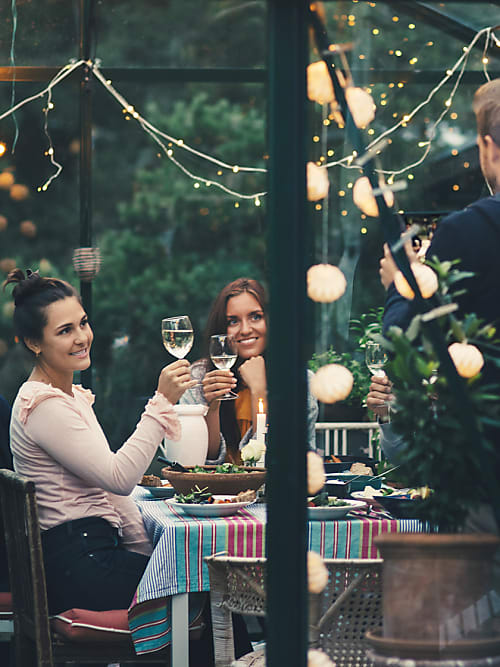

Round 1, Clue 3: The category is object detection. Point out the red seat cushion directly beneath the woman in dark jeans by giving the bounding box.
[50,609,130,642]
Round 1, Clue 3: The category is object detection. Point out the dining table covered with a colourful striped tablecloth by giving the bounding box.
[128,487,427,667]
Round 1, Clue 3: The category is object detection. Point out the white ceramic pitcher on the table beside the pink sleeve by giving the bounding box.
[163,404,208,466]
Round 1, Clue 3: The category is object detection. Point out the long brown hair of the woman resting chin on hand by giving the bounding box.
[204,278,267,461]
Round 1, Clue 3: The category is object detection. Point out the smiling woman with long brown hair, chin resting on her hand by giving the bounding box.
[180,278,318,463]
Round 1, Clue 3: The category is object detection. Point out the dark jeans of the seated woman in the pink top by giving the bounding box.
[42,517,149,614]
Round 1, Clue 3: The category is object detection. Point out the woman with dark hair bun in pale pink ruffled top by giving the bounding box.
[5,269,195,614]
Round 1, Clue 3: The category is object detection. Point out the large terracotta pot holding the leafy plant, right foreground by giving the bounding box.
[369,533,500,659]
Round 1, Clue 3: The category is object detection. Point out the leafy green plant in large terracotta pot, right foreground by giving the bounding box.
[371,261,500,665]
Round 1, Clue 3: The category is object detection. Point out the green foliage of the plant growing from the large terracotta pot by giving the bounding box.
[378,260,500,532]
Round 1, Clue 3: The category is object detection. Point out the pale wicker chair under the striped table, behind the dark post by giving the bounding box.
[205,556,382,667]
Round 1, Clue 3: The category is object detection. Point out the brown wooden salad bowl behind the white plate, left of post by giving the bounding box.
[161,466,266,496]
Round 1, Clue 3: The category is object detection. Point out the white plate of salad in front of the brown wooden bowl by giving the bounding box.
[168,489,257,518]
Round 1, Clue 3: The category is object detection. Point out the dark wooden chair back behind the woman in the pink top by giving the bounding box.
[0,469,53,666]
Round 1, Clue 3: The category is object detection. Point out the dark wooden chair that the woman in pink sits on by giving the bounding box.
[0,469,207,667]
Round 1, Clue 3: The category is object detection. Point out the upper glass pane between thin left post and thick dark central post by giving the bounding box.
[96,0,266,68]
